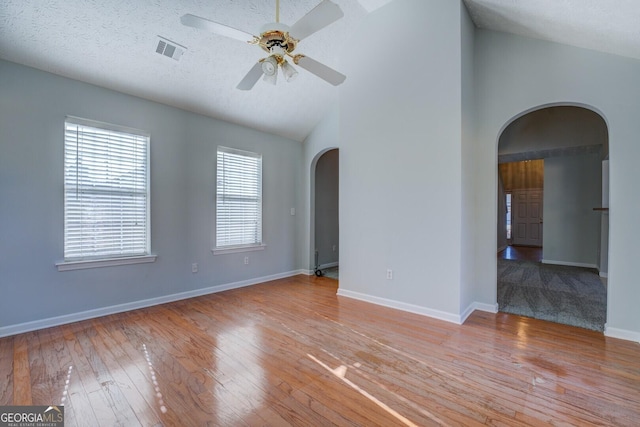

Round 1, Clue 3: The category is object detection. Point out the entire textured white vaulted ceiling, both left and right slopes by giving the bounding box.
[0,0,640,141]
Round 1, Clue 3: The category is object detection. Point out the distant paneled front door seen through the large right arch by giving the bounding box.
[511,189,543,247]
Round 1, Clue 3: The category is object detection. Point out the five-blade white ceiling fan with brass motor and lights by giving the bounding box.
[180,0,346,90]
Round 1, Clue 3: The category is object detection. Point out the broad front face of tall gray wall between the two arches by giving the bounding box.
[339,0,462,321]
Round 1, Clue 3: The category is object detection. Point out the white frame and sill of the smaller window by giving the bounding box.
[211,145,266,255]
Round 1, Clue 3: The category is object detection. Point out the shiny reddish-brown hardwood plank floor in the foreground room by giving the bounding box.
[0,276,640,426]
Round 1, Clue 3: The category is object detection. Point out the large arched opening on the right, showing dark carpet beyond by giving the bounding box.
[497,105,609,331]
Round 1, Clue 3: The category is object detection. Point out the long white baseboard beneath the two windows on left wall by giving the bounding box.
[0,270,313,338]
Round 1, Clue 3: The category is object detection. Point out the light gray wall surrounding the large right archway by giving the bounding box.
[475,30,640,340]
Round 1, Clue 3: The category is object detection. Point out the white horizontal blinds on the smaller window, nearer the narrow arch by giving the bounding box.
[216,147,262,248]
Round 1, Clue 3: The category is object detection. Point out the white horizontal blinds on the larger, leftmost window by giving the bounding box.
[64,118,150,261]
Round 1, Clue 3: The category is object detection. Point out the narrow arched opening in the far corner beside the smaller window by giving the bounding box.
[310,148,340,279]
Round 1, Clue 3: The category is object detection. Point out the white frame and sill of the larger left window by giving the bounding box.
[56,116,157,271]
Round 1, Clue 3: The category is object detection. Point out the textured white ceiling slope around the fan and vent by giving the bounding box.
[0,0,375,140]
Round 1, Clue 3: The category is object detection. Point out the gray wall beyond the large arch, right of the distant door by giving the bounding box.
[543,154,602,268]
